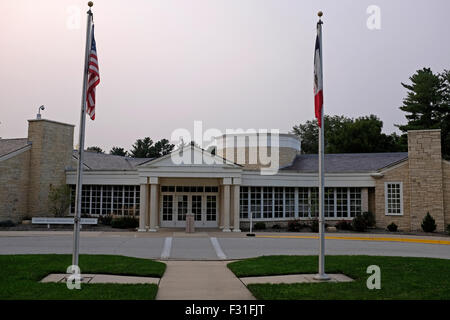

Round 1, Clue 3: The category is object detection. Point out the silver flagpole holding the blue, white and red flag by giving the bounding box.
[314,11,330,280]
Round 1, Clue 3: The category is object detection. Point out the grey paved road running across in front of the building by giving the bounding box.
[0,232,450,260]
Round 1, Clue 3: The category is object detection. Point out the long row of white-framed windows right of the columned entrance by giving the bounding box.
[240,187,362,219]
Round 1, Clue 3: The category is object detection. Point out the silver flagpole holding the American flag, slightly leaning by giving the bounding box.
[72,1,94,266]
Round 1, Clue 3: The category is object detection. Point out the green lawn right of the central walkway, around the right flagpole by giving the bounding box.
[228,256,450,300]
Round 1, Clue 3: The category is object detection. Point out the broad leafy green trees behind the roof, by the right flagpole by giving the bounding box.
[293,115,407,154]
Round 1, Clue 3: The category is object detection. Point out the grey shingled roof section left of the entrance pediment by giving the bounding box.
[71,150,151,171]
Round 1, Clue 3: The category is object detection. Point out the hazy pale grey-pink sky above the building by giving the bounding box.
[0,0,450,151]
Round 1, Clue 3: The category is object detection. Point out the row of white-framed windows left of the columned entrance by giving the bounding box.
[70,185,140,216]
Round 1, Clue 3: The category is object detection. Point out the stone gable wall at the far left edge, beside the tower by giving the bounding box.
[0,149,31,222]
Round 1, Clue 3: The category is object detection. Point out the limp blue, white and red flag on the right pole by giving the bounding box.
[314,22,323,127]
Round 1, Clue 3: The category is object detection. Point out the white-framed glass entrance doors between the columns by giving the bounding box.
[160,193,218,228]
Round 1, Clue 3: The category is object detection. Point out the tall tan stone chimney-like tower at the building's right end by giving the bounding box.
[408,129,444,231]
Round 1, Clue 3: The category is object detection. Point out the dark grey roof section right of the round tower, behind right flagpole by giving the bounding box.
[281,152,408,173]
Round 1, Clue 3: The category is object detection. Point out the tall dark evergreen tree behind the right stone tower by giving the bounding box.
[397,68,450,159]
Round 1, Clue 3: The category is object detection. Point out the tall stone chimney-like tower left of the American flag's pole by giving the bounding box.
[28,119,74,216]
